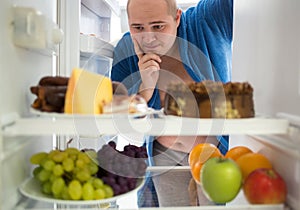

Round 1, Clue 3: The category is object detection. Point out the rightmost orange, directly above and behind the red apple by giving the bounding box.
[236,153,272,180]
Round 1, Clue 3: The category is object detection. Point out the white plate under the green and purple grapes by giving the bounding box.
[19,177,145,205]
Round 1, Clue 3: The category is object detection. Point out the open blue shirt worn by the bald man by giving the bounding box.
[111,0,233,207]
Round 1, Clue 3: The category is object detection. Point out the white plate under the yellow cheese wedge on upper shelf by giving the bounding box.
[30,108,157,119]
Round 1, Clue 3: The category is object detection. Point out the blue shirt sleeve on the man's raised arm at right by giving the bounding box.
[178,0,233,82]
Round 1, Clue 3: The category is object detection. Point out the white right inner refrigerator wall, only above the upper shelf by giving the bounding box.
[233,0,300,115]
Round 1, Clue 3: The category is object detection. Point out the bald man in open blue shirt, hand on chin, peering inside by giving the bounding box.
[111,0,233,206]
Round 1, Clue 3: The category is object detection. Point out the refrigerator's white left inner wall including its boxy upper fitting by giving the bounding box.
[0,0,58,210]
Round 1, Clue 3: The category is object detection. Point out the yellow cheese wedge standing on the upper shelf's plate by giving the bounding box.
[64,68,113,114]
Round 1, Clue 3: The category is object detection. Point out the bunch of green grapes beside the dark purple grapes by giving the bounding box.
[30,148,113,200]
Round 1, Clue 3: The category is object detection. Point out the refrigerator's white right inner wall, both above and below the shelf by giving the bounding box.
[231,0,300,209]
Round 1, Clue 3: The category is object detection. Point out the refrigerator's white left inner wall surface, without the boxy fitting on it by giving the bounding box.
[0,0,56,210]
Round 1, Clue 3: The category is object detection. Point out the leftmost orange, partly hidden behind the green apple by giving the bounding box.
[189,143,223,183]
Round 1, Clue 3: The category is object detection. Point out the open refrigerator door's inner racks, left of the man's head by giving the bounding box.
[80,0,120,76]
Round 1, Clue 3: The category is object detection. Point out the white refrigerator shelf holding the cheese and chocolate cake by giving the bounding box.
[2,114,289,137]
